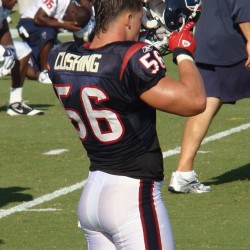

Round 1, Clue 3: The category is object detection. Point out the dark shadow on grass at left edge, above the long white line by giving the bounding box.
[0,187,33,207]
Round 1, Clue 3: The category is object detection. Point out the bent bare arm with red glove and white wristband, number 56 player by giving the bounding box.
[141,22,206,116]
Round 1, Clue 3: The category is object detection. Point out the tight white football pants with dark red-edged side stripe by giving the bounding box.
[78,171,174,250]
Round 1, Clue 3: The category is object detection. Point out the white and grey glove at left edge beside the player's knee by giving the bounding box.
[0,45,16,77]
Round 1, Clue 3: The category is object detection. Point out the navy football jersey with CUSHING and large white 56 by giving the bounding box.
[48,42,166,180]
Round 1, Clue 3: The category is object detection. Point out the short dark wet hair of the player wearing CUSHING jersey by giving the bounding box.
[93,0,142,33]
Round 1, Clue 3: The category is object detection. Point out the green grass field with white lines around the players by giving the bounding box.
[0,10,250,250]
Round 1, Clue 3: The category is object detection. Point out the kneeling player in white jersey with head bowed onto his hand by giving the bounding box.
[17,0,91,83]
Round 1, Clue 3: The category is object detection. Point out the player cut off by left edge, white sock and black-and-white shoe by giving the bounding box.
[0,0,44,116]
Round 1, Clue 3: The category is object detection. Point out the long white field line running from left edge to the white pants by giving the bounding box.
[0,180,86,219]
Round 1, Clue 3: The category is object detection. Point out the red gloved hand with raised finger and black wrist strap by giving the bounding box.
[168,22,196,60]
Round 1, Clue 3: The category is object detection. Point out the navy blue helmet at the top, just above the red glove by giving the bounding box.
[164,0,201,32]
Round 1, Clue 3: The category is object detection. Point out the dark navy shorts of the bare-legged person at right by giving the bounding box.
[197,60,250,103]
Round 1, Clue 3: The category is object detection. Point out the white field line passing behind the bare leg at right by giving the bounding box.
[162,123,250,158]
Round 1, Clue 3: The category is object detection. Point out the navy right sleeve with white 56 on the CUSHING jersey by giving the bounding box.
[124,44,166,96]
